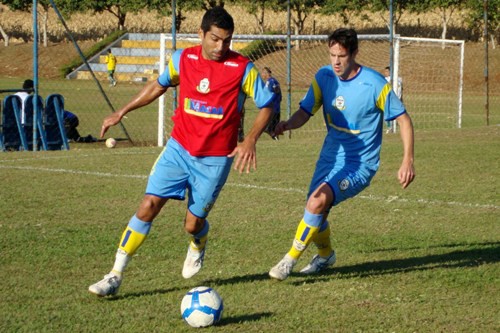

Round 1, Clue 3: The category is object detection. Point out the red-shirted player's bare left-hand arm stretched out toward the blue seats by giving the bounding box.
[101,80,167,138]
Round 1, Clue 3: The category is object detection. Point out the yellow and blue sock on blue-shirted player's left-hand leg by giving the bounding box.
[288,210,323,260]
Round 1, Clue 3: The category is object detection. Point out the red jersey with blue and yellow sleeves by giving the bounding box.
[158,45,274,157]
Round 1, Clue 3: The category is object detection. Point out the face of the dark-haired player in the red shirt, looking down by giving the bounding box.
[199,25,233,61]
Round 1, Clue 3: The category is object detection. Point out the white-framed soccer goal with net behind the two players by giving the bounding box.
[158,34,464,146]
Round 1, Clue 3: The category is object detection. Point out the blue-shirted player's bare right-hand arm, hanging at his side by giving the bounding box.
[396,113,415,188]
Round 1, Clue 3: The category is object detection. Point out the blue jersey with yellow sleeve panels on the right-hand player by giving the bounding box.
[300,66,406,170]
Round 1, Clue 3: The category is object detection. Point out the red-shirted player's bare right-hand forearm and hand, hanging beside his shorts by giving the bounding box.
[227,107,273,173]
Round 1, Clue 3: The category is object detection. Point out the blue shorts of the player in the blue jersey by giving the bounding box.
[307,158,376,206]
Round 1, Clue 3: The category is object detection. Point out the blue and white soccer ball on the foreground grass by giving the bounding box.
[181,287,224,327]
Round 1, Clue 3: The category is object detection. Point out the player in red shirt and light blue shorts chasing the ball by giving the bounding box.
[89,7,274,296]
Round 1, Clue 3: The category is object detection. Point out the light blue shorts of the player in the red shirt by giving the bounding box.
[146,138,233,218]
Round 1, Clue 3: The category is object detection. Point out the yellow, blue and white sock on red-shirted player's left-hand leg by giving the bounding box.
[112,215,152,276]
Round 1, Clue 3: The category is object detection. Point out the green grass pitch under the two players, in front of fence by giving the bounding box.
[0,126,500,332]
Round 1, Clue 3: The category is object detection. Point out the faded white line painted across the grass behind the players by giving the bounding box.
[0,165,500,209]
